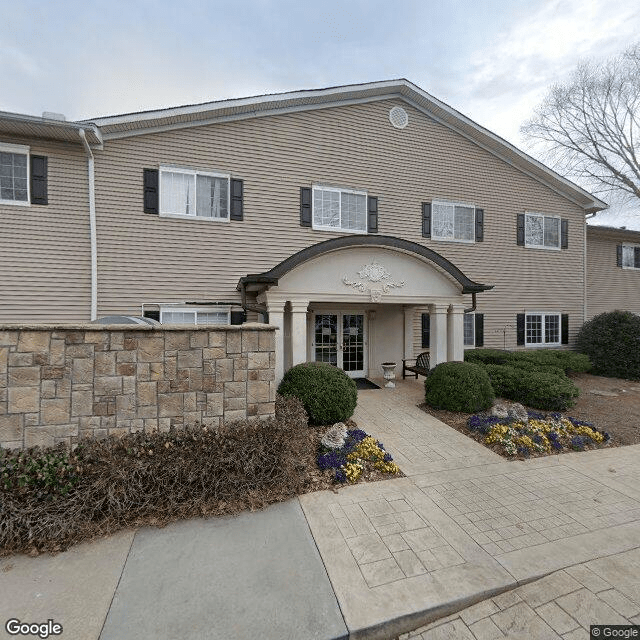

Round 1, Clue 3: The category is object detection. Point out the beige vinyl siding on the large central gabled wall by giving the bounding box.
[96,100,584,346]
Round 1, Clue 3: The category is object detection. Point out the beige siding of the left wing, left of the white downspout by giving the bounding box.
[0,137,91,322]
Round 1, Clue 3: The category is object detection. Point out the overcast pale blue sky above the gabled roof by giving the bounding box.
[0,0,640,225]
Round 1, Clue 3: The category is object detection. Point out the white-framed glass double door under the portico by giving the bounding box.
[312,313,366,378]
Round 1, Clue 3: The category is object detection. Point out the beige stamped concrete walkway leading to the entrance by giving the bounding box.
[300,381,640,639]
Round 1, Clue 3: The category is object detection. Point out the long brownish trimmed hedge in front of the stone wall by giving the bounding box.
[0,398,317,556]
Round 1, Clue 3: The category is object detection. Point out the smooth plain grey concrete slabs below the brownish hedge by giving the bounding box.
[0,500,347,640]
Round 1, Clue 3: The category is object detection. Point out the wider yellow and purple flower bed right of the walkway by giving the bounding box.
[467,411,610,458]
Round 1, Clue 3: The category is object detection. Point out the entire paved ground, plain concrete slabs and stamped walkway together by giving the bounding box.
[0,381,640,640]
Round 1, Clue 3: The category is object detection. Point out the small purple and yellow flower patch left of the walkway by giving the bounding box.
[318,429,402,483]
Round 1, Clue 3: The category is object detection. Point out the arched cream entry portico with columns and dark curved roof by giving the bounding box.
[239,235,492,380]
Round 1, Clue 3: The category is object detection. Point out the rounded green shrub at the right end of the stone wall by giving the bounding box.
[278,362,358,424]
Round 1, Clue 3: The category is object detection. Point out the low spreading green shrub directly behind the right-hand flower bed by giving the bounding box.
[485,363,580,411]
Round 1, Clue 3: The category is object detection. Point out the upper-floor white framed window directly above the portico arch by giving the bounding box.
[312,185,367,233]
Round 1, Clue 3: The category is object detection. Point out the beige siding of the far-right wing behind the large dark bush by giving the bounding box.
[587,227,640,318]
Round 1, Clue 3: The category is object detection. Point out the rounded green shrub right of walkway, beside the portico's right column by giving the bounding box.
[424,362,494,413]
